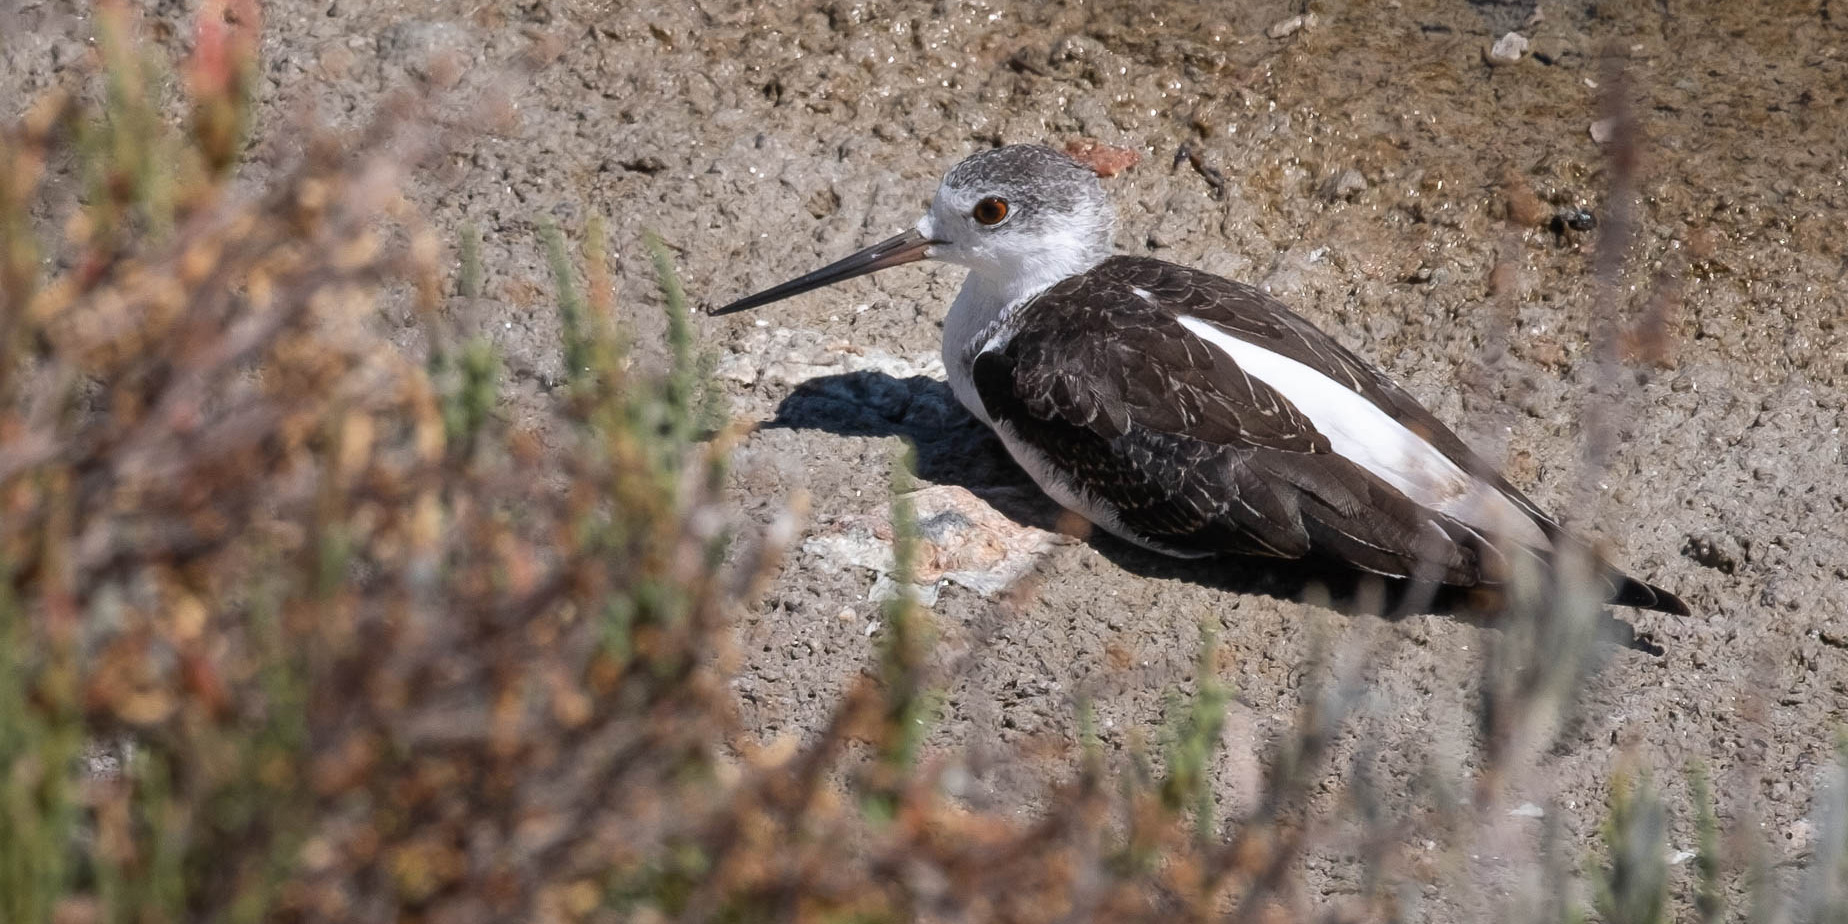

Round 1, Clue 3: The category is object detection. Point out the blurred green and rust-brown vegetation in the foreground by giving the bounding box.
[0,0,1848,924]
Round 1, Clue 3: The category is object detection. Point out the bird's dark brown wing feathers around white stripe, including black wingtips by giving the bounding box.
[972,257,1687,614]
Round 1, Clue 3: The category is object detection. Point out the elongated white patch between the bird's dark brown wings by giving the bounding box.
[1177,314,1552,549]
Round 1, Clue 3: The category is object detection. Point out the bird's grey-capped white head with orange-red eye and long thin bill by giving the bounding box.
[711,144,1116,314]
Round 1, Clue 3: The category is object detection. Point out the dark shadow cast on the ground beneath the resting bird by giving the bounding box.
[763,371,1661,654]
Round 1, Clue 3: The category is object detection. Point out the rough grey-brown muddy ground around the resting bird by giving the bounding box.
[0,0,1848,920]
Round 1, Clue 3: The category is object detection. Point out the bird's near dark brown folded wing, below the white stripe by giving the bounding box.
[974,261,1493,586]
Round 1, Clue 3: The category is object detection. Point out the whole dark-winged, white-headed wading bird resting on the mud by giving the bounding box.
[710,144,1689,615]
